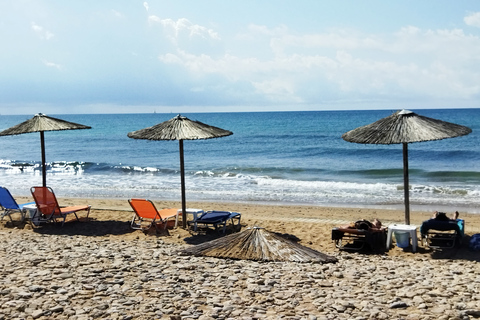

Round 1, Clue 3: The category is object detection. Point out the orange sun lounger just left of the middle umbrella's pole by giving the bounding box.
[128,199,178,231]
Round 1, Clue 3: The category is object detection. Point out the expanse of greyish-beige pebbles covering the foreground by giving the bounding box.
[0,230,480,320]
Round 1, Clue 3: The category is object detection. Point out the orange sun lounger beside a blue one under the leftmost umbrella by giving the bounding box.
[30,187,91,226]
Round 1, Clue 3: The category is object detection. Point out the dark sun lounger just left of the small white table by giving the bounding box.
[332,227,387,253]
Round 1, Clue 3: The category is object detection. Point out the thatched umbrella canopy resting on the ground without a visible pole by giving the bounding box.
[180,227,337,263]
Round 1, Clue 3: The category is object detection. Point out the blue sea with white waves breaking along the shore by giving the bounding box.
[0,109,480,213]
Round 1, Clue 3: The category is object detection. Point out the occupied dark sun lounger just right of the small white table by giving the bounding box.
[420,219,465,249]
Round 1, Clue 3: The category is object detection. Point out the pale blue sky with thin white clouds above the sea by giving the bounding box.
[0,0,480,115]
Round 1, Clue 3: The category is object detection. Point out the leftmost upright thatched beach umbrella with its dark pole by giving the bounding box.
[0,113,91,187]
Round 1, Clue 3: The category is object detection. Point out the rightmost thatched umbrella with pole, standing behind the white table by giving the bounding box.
[342,110,472,224]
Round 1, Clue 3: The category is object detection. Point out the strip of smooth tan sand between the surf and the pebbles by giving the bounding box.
[8,197,480,259]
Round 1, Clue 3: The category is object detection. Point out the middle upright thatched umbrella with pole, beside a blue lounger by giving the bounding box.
[128,115,233,228]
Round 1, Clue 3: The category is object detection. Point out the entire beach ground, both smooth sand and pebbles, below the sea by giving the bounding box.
[0,197,480,319]
